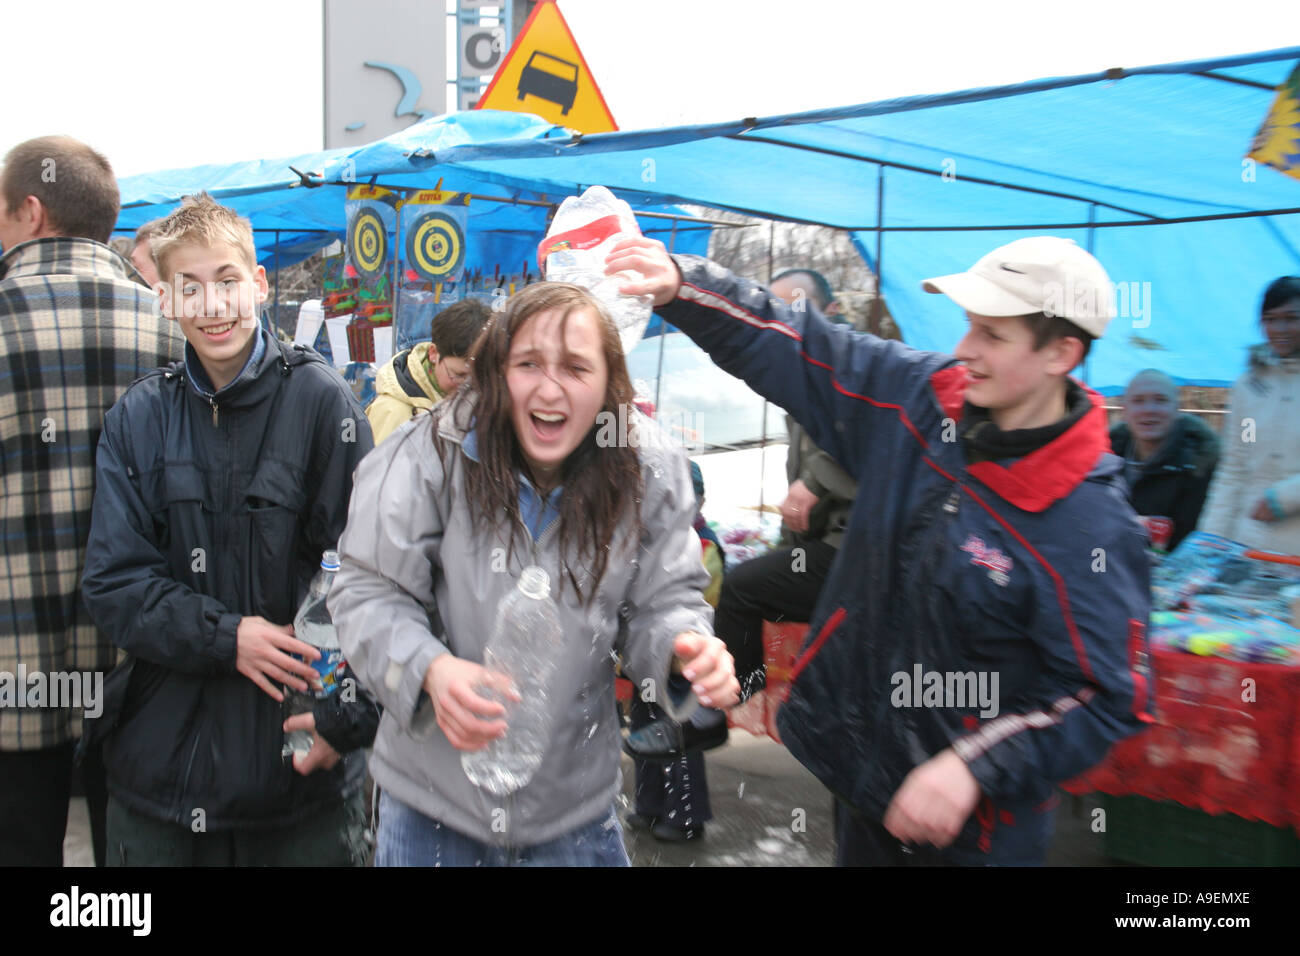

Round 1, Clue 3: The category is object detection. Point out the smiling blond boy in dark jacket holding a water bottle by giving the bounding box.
[82,194,378,866]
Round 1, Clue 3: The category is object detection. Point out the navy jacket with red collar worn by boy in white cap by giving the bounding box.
[659,256,1151,852]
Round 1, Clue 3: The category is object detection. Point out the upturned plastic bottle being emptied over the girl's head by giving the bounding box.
[537,186,653,355]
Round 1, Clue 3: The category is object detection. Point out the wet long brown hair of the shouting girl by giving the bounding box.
[434,282,644,602]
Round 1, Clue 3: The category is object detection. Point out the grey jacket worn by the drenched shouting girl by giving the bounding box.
[329,393,712,847]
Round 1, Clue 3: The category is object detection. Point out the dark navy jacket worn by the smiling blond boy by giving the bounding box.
[82,330,378,830]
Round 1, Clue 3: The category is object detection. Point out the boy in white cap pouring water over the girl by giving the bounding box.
[606,237,1152,865]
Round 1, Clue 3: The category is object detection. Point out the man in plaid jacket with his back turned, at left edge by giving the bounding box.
[0,137,185,866]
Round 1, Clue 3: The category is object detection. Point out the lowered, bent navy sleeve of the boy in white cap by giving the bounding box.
[953,512,1152,803]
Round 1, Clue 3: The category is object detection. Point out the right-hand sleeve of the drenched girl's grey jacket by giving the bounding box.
[623,450,714,701]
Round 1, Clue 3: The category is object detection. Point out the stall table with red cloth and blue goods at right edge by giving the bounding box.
[1066,532,1300,864]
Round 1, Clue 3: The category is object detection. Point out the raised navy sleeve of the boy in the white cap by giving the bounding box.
[658,255,940,479]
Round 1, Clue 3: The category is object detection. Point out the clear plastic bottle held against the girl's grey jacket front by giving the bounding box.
[460,567,563,796]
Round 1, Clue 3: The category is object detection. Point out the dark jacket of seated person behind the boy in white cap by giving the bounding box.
[1110,414,1219,551]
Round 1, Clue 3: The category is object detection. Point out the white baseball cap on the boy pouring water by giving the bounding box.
[920,235,1115,338]
